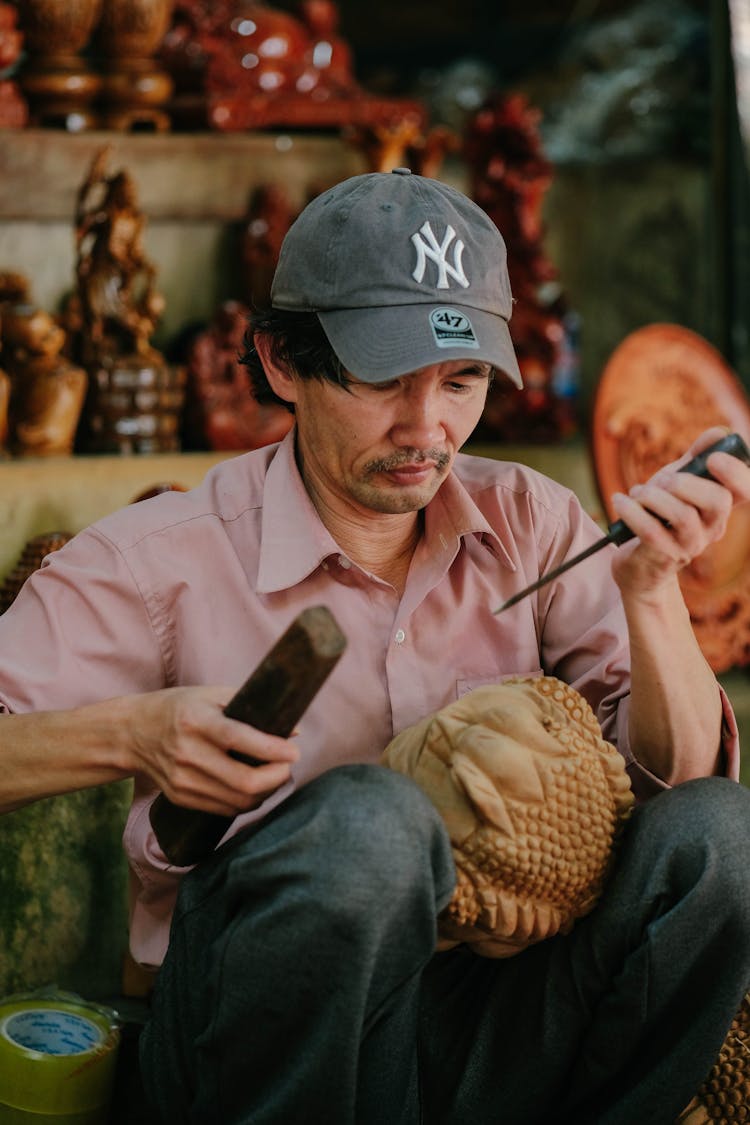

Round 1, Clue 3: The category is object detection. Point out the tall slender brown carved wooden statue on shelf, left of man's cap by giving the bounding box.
[67,149,184,453]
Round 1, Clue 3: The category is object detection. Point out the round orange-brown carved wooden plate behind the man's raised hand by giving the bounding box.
[590,324,750,672]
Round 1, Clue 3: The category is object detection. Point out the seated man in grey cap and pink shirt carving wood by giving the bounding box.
[0,169,750,1125]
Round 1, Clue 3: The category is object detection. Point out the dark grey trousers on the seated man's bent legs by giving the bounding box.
[141,766,750,1125]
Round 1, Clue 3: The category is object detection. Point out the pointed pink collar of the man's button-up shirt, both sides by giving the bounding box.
[257,426,515,594]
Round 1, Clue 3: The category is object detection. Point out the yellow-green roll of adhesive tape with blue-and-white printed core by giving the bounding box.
[0,991,119,1125]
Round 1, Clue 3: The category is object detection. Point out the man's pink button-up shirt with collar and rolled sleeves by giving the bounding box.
[0,431,739,965]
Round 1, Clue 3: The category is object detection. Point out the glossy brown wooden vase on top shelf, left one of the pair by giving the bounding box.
[18,0,101,132]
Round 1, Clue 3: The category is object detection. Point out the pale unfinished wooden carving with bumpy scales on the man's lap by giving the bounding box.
[382,676,633,957]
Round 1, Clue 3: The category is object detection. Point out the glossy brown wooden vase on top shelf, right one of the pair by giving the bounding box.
[98,0,173,132]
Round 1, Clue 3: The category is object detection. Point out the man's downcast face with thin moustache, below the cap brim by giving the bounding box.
[293,360,490,513]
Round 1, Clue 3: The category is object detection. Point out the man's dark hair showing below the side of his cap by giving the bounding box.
[240,308,351,414]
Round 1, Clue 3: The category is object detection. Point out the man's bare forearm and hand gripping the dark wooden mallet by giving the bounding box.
[0,686,299,817]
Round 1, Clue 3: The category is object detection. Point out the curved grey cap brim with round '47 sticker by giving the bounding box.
[317,302,523,387]
